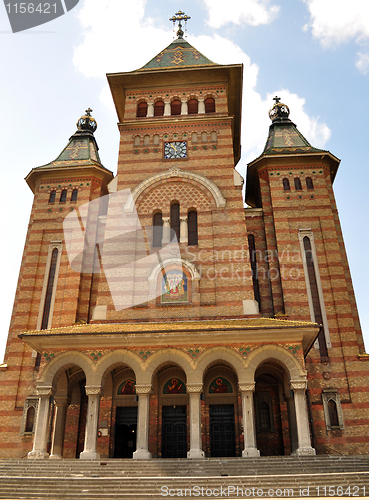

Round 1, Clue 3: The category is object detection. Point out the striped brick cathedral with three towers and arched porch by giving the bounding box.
[0,12,369,459]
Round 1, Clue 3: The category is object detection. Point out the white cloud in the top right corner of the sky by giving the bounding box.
[304,0,369,47]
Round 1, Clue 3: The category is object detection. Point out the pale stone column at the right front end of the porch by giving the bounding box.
[291,380,315,455]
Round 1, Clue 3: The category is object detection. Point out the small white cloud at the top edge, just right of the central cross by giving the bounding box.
[204,0,279,28]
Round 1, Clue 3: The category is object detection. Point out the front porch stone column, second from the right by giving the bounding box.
[238,384,260,457]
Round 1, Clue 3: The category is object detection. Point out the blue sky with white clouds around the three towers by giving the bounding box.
[0,0,369,363]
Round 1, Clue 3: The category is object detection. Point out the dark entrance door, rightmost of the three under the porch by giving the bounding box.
[209,405,236,457]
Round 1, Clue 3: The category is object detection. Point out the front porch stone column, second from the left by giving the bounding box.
[79,385,101,460]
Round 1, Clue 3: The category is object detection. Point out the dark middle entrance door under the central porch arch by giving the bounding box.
[161,406,187,458]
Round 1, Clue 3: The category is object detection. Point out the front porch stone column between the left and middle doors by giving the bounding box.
[133,384,151,460]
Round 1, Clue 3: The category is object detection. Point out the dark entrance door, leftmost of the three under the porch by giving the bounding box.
[114,406,137,458]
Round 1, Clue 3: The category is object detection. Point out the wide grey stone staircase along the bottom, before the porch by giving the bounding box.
[0,455,369,500]
